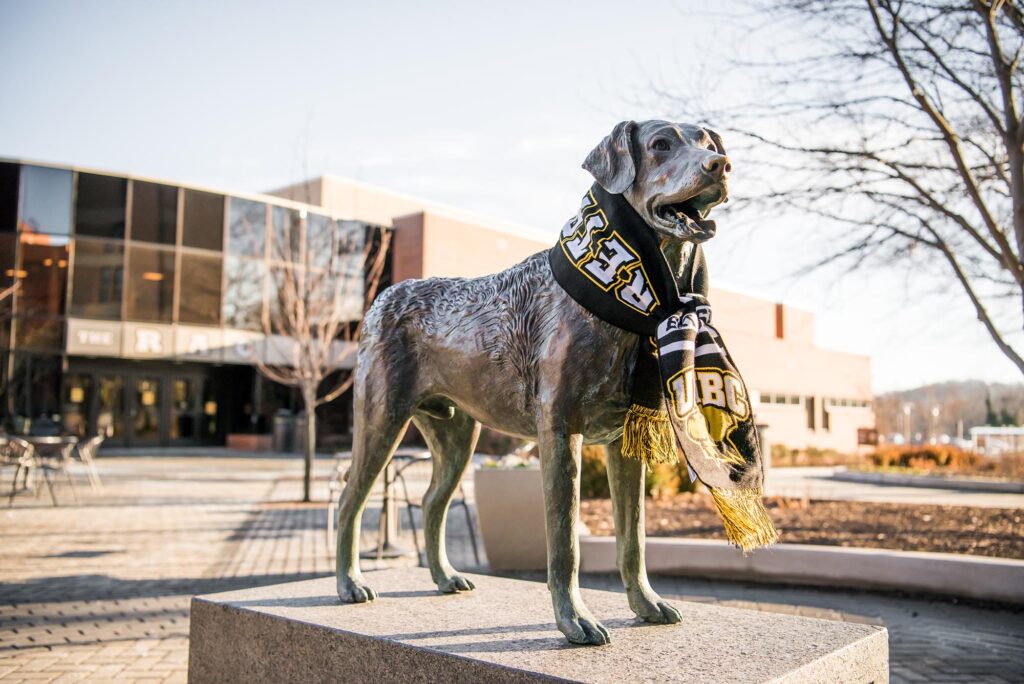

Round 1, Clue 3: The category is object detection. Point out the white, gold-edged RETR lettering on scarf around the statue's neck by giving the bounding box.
[558,191,659,315]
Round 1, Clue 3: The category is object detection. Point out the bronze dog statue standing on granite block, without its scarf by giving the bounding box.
[337,121,731,644]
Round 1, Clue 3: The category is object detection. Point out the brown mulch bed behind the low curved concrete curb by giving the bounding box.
[581,494,1024,559]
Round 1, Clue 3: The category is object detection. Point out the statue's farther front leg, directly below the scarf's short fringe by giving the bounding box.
[607,439,682,625]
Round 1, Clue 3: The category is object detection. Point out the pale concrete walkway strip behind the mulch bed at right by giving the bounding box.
[765,466,1024,508]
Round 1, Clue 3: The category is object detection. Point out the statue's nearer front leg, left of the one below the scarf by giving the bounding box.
[538,427,611,645]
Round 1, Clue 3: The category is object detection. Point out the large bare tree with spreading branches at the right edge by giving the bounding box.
[657,0,1024,374]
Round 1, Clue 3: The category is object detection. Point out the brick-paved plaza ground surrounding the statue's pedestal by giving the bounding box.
[0,457,1024,682]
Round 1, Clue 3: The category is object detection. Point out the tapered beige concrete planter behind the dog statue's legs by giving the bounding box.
[473,467,548,570]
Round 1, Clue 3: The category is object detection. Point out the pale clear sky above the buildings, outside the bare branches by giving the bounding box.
[0,0,1020,391]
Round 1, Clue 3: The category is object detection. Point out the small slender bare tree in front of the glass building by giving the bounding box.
[255,212,391,502]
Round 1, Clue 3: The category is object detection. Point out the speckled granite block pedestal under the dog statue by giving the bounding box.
[188,568,889,684]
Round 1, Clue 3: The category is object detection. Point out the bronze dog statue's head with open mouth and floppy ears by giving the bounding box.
[583,121,732,243]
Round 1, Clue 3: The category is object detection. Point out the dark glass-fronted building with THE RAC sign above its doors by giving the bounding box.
[0,161,379,446]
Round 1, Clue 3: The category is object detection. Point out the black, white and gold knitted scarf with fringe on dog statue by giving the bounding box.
[548,183,778,552]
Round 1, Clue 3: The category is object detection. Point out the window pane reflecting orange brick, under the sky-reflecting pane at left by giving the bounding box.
[15,233,69,315]
